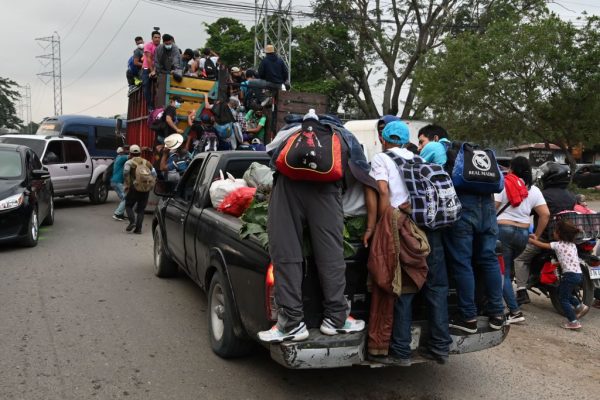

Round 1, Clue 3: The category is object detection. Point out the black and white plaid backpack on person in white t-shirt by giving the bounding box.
[385,150,462,229]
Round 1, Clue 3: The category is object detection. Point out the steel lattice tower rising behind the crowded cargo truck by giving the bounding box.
[254,0,292,82]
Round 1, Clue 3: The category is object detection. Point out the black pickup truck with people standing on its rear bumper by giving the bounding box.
[152,151,509,368]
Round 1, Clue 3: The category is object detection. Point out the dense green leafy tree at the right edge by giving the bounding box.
[417,14,600,166]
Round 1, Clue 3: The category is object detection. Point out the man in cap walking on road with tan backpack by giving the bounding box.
[123,144,156,234]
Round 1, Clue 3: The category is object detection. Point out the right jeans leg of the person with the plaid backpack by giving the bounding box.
[422,229,452,356]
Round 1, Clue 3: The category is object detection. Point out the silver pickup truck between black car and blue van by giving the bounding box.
[0,134,113,204]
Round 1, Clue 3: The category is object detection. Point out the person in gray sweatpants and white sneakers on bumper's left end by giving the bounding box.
[258,110,365,343]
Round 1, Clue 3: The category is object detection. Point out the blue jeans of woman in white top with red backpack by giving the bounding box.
[498,225,529,313]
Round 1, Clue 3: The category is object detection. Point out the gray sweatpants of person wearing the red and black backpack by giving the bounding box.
[268,175,349,332]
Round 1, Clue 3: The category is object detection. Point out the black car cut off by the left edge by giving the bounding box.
[0,144,54,247]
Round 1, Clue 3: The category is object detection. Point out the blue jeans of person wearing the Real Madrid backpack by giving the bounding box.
[444,193,504,321]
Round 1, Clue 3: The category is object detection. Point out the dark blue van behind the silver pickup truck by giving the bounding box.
[36,115,126,158]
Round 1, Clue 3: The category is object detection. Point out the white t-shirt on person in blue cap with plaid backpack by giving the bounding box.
[369,147,415,208]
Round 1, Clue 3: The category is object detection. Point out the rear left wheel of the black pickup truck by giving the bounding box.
[206,271,252,358]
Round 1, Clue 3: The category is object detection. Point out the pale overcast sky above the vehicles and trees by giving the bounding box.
[0,0,600,121]
